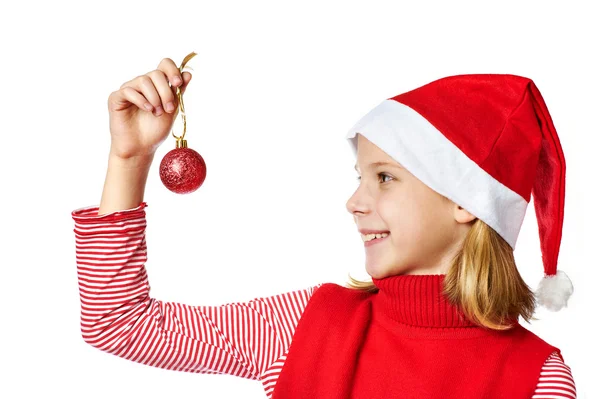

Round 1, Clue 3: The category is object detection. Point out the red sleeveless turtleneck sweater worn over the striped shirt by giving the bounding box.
[273,275,562,399]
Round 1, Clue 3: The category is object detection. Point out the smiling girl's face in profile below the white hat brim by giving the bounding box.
[346,134,475,278]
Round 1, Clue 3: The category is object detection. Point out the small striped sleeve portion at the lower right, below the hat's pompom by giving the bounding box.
[532,352,577,399]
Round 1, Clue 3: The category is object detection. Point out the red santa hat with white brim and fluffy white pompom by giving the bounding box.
[347,74,573,311]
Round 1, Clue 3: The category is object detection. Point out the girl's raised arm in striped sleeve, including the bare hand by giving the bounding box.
[77,58,326,396]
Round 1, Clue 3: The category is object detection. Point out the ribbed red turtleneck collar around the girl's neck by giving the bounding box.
[373,274,478,329]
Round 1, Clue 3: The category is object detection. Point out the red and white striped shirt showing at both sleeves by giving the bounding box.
[72,202,576,399]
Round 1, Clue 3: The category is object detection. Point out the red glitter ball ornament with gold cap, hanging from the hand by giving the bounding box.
[160,140,206,194]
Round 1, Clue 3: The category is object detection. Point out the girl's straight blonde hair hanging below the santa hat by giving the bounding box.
[346,219,537,330]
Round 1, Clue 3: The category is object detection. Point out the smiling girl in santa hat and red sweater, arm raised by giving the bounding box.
[72,58,576,399]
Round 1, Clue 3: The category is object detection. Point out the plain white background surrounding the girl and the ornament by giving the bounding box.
[0,0,600,399]
